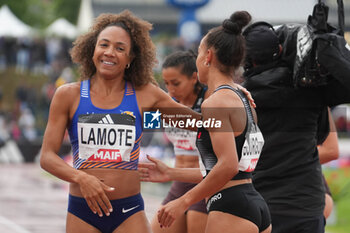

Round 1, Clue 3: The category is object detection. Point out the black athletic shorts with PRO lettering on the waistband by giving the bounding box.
[207,183,271,232]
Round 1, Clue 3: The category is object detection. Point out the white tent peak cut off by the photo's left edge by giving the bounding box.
[0,5,33,37]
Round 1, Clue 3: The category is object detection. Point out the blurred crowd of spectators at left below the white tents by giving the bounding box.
[0,37,74,144]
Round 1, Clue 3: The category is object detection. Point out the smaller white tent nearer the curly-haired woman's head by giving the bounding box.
[45,18,78,39]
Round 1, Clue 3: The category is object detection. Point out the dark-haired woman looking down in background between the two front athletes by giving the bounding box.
[151,51,207,233]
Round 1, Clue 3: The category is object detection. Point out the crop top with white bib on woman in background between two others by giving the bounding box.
[164,87,207,156]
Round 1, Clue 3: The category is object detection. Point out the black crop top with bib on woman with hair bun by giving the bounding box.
[196,85,264,180]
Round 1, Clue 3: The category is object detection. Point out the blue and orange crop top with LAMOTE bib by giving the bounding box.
[68,80,142,170]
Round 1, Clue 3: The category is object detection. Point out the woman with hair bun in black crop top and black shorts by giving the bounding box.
[141,11,271,233]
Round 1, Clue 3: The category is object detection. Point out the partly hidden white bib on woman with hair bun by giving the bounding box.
[238,125,264,172]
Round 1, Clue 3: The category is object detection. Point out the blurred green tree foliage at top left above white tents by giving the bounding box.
[0,0,81,29]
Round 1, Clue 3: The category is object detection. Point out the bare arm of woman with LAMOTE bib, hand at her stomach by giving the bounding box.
[40,84,114,216]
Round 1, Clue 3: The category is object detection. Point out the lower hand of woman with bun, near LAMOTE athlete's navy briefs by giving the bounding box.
[158,198,188,228]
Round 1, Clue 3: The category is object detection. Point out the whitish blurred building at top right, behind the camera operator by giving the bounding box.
[198,0,350,27]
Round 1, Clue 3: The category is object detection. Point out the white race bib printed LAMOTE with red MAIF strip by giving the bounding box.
[78,114,136,162]
